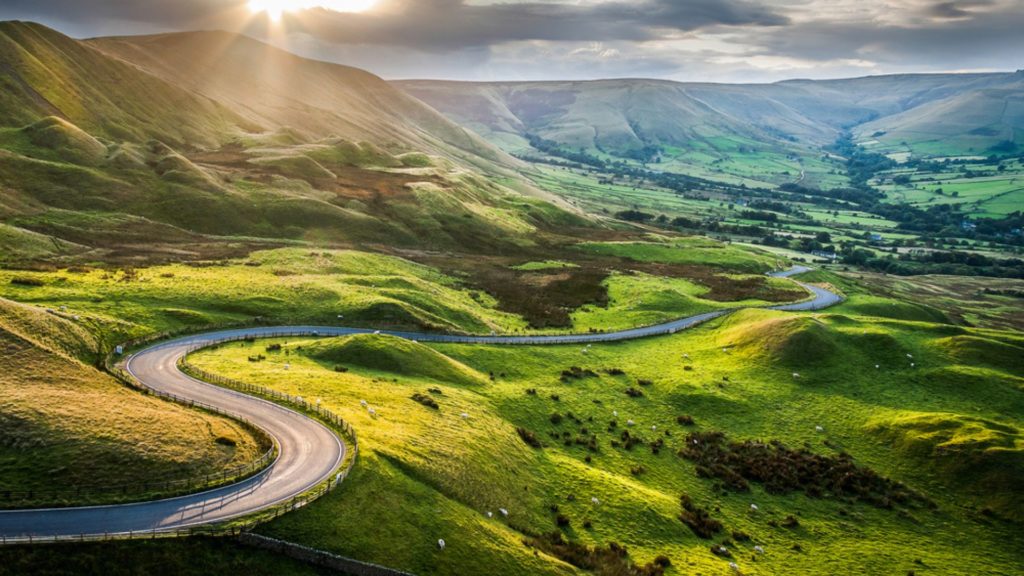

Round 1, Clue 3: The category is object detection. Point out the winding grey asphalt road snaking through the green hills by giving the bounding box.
[0,266,842,542]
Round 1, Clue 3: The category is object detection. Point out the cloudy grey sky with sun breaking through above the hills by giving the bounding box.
[0,0,1024,82]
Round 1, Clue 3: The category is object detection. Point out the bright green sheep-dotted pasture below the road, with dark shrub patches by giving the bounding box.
[191,305,1024,575]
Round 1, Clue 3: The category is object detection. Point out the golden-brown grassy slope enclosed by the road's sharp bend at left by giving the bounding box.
[0,300,267,508]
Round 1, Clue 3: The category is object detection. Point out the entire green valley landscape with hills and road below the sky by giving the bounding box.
[0,15,1024,576]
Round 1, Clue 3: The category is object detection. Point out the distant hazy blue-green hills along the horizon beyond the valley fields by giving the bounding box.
[396,74,1021,179]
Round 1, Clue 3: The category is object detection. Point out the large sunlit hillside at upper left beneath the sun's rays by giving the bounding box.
[0,23,586,263]
